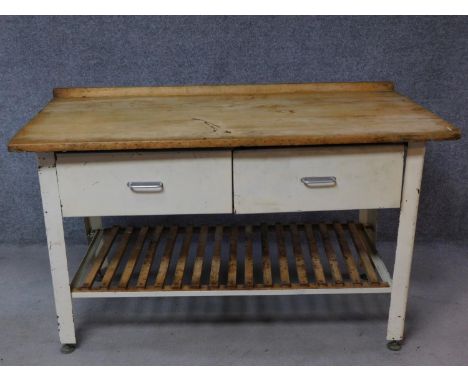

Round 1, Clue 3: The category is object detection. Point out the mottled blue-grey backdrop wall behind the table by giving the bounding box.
[0,16,468,243]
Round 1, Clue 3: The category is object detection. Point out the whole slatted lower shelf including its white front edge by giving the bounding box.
[71,222,391,297]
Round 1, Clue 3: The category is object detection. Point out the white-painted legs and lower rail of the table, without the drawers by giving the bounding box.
[38,142,425,344]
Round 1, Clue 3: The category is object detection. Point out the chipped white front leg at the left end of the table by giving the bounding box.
[38,153,76,344]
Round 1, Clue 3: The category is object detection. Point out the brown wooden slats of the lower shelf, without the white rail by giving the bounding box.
[76,222,390,292]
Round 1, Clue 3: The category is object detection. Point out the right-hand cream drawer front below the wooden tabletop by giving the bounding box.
[233,145,404,213]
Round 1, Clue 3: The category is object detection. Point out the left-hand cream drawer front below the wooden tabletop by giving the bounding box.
[57,150,232,216]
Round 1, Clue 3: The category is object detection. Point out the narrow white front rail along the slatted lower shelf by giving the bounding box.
[72,287,391,298]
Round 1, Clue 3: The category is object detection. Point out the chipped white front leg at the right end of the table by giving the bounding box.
[387,143,425,340]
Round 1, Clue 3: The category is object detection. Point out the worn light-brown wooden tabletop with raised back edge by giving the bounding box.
[8,82,460,152]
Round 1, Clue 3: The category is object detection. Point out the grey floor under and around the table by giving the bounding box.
[0,242,468,365]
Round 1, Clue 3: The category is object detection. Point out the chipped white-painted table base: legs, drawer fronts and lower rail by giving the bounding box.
[34,143,424,344]
